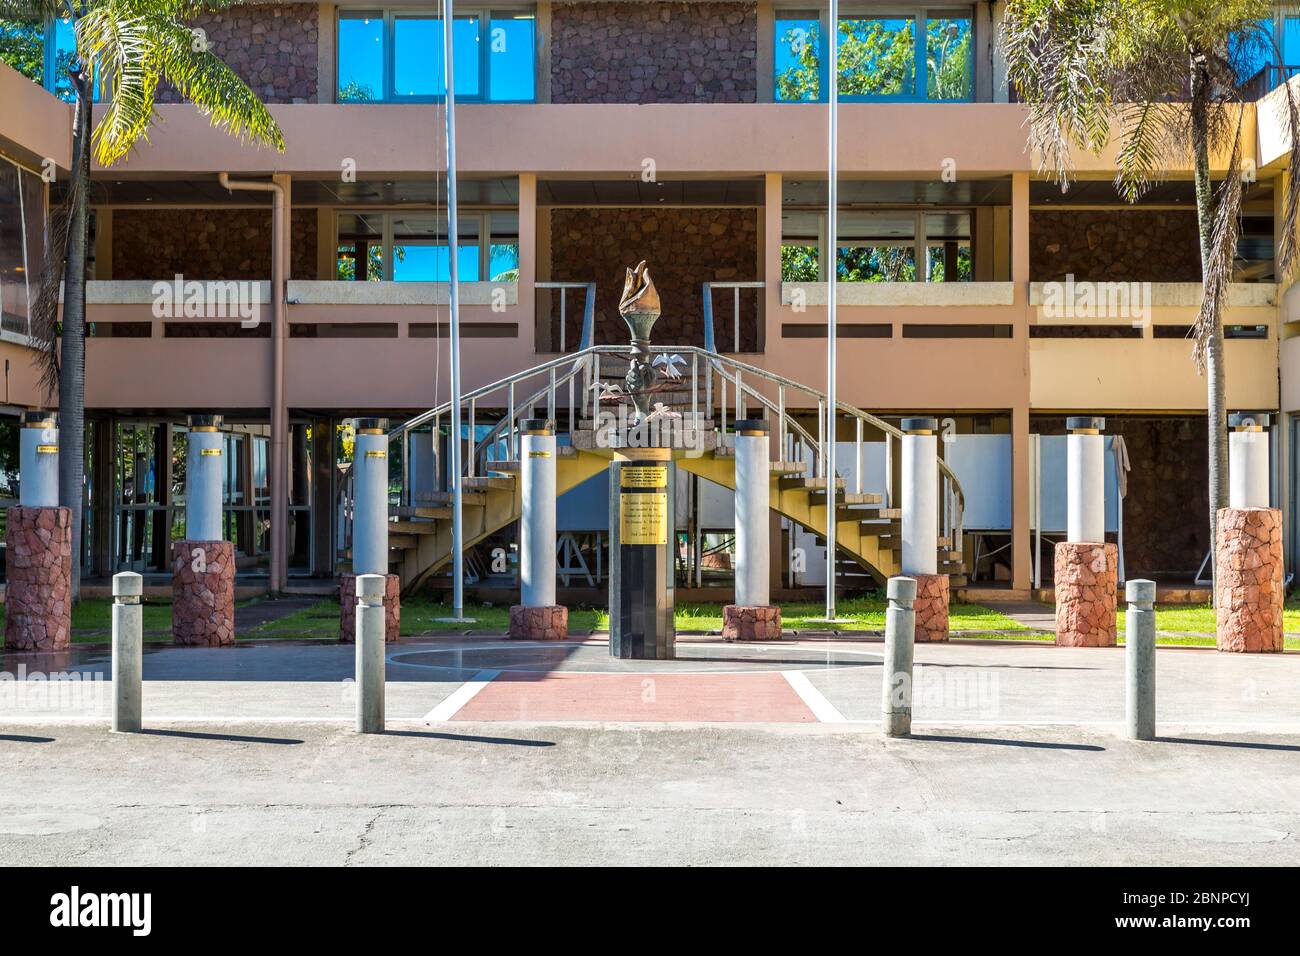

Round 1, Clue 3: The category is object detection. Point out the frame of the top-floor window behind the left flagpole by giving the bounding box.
[332,3,541,105]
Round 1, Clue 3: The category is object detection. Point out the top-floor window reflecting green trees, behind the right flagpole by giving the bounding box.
[774,8,974,103]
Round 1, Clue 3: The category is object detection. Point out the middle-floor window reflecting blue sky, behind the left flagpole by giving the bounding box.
[335,211,519,282]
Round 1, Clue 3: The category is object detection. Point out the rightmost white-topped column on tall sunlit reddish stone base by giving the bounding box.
[1214,414,1284,653]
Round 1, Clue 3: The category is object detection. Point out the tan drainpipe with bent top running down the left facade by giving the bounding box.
[217,173,289,593]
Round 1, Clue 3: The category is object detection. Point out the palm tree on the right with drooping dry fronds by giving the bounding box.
[1000,0,1300,598]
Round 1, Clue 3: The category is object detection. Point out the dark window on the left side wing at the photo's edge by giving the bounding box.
[0,159,46,334]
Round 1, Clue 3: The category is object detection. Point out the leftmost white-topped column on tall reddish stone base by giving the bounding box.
[4,411,73,650]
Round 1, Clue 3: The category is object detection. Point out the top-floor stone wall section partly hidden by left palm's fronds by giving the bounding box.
[157,4,320,103]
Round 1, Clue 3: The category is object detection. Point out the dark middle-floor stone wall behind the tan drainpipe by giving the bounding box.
[113,208,316,280]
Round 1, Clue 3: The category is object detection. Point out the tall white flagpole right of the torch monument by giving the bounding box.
[826,0,840,620]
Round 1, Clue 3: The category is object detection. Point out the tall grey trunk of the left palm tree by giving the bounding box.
[59,74,92,601]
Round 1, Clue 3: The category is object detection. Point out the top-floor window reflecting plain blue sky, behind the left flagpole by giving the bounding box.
[337,9,537,103]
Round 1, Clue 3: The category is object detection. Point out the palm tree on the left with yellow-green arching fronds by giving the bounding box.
[0,0,285,598]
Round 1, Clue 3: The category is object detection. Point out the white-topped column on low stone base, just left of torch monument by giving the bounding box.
[510,419,568,641]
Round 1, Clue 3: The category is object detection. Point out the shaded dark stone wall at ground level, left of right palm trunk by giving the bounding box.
[1034,415,1210,580]
